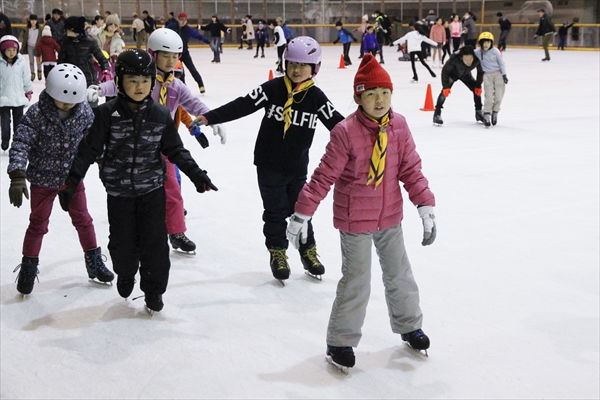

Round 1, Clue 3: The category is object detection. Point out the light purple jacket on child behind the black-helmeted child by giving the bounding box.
[98,71,210,119]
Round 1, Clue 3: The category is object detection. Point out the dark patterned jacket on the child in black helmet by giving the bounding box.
[69,96,204,197]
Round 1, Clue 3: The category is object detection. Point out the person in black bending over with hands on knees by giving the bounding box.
[433,46,484,125]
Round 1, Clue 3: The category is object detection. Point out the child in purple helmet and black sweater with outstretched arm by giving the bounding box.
[191,36,344,283]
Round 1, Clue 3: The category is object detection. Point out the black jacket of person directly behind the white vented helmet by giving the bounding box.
[57,33,109,86]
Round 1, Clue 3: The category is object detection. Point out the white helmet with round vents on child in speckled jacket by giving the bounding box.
[46,63,87,104]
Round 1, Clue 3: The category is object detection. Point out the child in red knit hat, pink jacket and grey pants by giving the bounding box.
[287,54,436,372]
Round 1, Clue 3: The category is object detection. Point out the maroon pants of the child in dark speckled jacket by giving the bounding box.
[23,182,98,257]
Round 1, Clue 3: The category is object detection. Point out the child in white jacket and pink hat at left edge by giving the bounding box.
[0,35,33,150]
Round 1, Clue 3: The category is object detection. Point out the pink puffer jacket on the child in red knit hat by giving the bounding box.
[295,108,435,233]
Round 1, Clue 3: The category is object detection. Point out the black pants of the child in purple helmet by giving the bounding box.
[256,167,315,250]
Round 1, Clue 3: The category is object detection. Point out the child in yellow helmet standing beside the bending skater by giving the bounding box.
[475,32,508,128]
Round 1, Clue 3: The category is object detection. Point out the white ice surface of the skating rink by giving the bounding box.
[0,45,600,399]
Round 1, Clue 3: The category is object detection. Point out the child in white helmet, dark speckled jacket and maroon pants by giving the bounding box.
[8,64,114,295]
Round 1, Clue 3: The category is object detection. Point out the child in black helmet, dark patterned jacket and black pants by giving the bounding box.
[59,49,217,312]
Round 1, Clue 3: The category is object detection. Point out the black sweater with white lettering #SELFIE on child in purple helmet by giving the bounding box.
[204,77,344,174]
